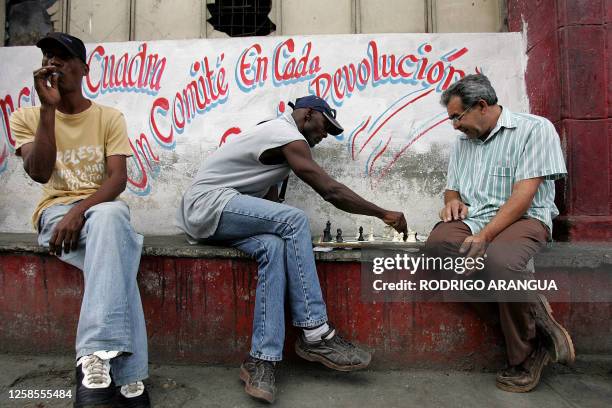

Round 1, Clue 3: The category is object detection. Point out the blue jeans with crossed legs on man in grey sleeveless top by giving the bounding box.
[205,195,327,361]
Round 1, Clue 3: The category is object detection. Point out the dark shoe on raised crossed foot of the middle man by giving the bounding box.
[295,326,372,371]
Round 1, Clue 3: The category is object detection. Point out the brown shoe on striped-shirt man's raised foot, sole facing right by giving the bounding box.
[533,294,576,364]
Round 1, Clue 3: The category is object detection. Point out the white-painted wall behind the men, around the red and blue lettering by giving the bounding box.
[0,33,528,235]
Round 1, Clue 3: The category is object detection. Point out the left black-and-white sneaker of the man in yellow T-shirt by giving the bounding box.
[74,354,115,408]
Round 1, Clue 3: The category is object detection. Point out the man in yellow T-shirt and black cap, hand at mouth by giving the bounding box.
[11,33,150,407]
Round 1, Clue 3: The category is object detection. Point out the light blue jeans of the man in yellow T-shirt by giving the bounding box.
[38,201,148,385]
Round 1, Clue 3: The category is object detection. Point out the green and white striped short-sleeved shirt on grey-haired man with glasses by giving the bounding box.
[446,108,567,234]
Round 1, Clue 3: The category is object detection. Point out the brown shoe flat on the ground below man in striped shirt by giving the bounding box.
[495,346,550,392]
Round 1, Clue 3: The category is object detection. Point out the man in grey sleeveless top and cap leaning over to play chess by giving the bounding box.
[177,96,407,402]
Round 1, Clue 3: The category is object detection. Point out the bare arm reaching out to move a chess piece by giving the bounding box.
[282,141,407,233]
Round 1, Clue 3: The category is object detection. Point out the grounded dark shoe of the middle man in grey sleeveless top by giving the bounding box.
[240,356,276,404]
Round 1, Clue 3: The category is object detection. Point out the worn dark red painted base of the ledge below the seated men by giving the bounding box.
[0,253,612,369]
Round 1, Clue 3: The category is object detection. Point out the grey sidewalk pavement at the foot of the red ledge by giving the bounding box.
[0,354,612,408]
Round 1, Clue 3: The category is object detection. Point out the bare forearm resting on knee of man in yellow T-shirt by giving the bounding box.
[49,155,127,255]
